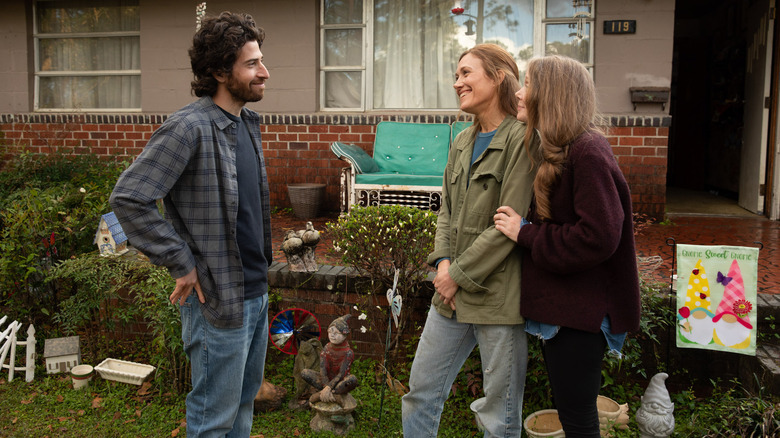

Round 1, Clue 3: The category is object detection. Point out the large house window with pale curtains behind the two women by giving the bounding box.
[320,0,594,111]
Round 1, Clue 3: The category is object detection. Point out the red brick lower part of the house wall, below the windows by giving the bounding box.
[0,114,671,219]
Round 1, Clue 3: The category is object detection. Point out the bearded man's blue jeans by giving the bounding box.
[181,294,268,438]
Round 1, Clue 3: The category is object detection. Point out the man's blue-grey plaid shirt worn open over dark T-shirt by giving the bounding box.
[110,96,273,328]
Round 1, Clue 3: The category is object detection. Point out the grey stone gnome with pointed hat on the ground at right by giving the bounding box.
[636,373,674,438]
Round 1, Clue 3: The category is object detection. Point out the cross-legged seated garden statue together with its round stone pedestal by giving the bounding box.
[301,315,358,434]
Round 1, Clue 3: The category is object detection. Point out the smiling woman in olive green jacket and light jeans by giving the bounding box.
[402,44,539,438]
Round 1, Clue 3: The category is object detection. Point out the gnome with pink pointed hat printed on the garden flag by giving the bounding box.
[712,260,753,349]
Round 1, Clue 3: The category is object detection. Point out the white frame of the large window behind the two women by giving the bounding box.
[319,0,596,112]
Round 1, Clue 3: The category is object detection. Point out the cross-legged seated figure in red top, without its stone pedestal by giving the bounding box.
[301,315,358,407]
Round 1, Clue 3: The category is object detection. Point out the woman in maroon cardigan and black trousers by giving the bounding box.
[494,56,640,438]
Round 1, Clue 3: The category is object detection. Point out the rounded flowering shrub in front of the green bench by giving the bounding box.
[327,205,437,360]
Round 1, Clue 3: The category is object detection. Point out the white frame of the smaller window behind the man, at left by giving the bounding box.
[33,0,141,113]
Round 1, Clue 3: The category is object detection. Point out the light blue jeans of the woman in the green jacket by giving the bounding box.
[401,308,528,438]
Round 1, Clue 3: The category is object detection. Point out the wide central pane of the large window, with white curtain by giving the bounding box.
[373,0,534,109]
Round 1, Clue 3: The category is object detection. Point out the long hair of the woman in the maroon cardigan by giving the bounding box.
[525,55,596,219]
